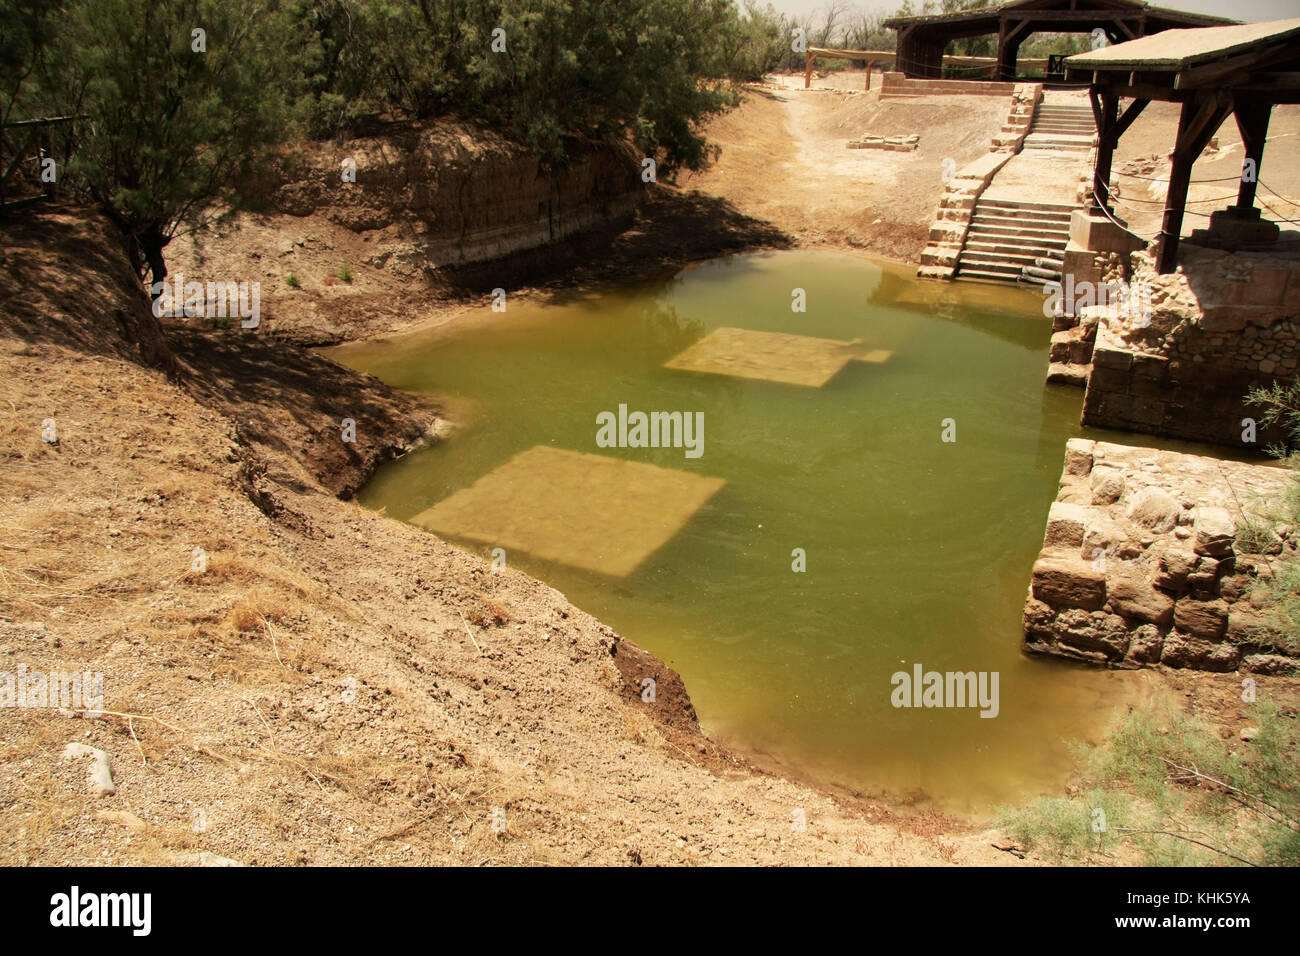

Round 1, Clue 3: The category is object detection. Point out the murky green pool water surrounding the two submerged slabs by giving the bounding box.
[330,251,1145,812]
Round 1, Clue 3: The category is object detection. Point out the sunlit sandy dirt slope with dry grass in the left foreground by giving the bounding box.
[0,211,1017,864]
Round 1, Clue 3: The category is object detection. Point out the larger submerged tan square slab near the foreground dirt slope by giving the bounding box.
[411,445,727,578]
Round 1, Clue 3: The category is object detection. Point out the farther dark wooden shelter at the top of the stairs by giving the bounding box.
[884,0,1236,81]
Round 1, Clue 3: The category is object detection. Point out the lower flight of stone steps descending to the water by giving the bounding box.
[956,198,1075,285]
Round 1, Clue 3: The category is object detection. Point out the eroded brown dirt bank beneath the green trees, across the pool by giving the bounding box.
[166,113,794,345]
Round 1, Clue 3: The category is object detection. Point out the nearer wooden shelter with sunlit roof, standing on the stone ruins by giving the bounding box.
[1065,18,1300,273]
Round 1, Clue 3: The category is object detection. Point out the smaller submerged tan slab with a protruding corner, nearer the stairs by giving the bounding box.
[664,328,893,388]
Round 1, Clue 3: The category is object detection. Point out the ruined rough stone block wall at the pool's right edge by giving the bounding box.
[1024,438,1300,672]
